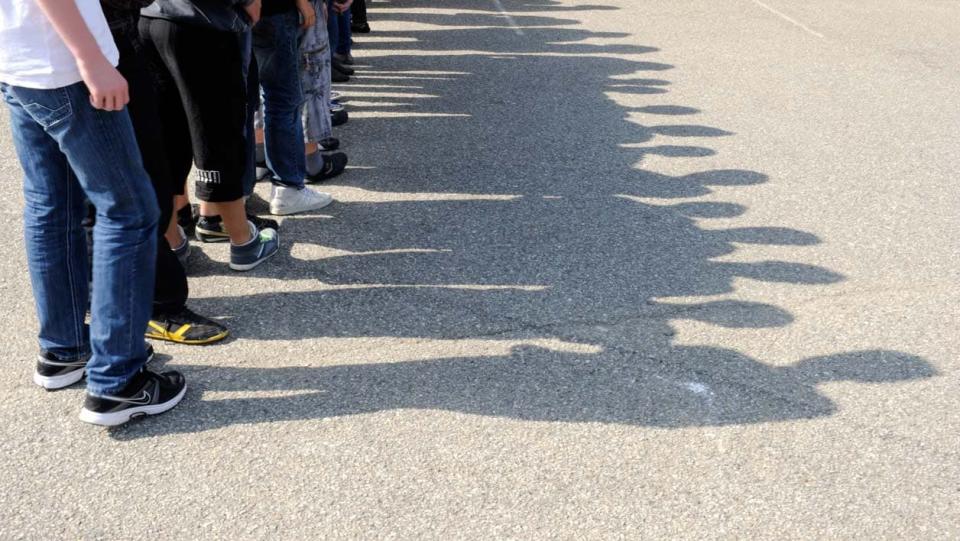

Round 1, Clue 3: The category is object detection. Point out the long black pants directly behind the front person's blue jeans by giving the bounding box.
[111,12,189,317]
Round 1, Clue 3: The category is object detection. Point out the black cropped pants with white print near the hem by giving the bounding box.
[139,17,252,203]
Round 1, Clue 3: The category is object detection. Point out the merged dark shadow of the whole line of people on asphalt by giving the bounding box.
[111,0,935,440]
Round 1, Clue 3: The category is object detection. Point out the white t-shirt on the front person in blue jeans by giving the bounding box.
[0,0,120,88]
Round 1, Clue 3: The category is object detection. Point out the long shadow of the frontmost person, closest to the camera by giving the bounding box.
[131,346,933,430]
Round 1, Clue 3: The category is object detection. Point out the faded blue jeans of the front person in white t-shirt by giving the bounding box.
[0,83,160,395]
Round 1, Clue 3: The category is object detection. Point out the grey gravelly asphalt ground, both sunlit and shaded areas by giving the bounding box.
[0,0,960,539]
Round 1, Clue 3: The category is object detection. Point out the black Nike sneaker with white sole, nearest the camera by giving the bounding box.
[80,368,187,426]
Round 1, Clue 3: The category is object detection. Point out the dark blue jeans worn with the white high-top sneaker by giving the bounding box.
[253,10,307,187]
